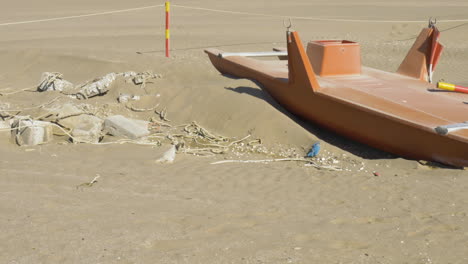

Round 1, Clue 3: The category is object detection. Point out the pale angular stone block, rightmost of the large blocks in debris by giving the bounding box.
[104,115,150,139]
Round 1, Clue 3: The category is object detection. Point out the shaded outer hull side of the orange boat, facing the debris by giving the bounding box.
[206,32,468,167]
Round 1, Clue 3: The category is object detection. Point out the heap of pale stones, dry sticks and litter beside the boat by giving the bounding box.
[0,71,354,171]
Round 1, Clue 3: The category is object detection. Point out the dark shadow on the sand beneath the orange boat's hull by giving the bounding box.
[224,83,398,159]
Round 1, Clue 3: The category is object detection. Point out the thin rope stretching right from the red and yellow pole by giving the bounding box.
[172,5,468,23]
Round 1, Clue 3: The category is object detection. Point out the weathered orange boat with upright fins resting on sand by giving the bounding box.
[205,24,468,167]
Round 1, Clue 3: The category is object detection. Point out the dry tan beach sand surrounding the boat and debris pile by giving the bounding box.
[0,0,468,263]
